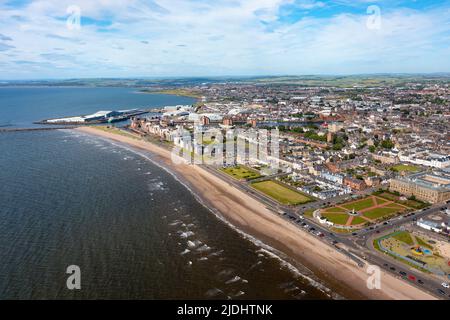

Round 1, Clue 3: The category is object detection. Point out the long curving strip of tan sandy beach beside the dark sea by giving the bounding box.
[75,127,435,300]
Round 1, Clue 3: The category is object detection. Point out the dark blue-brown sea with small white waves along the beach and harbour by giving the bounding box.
[0,88,328,299]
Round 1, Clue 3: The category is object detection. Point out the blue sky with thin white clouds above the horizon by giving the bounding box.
[0,0,450,79]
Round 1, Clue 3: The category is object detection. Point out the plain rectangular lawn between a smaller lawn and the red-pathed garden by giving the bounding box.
[252,181,313,205]
